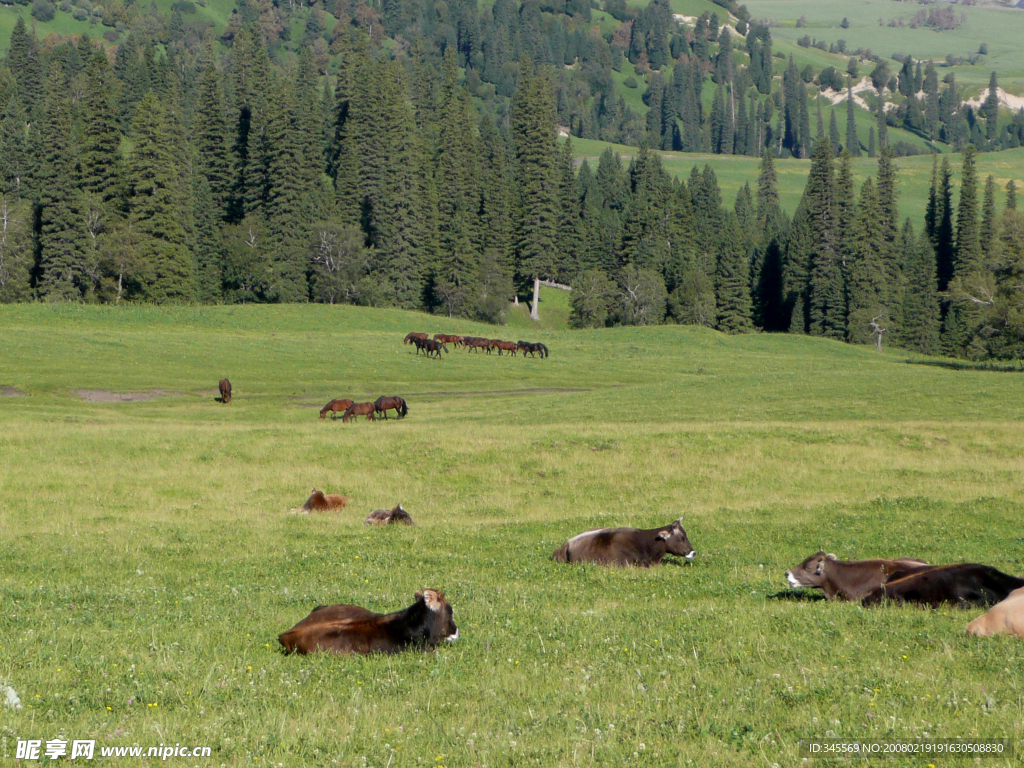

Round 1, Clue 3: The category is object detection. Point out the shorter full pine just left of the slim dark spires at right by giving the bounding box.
[900,219,939,354]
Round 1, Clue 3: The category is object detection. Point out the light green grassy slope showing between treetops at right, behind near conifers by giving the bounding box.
[572,138,1024,221]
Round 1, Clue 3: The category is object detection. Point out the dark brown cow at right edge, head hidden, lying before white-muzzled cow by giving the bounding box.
[861,563,1024,608]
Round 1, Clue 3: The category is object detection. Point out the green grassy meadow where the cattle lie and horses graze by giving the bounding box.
[0,303,1024,768]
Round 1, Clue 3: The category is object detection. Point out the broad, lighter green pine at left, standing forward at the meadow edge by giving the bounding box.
[128,91,196,303]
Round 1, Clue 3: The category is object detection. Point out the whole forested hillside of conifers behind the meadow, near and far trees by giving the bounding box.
[0,0,1024,357]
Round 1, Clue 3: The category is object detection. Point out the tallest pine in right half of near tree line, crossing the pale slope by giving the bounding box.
[804,136,846,339]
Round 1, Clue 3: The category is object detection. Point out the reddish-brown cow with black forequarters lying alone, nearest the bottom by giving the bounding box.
[278,590,459,653]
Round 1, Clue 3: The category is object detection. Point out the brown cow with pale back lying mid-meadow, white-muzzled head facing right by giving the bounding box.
[551,519,696,568]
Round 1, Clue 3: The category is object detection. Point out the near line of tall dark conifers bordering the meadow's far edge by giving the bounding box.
[0,17,1024,357]
